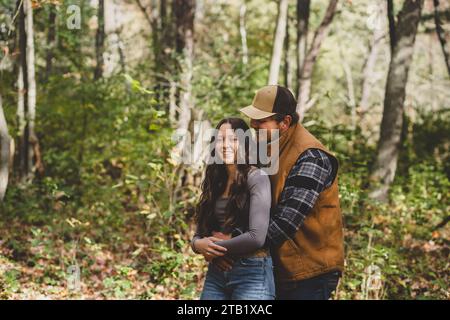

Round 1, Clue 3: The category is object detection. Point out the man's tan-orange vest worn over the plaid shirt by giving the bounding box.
[270,124,344,281]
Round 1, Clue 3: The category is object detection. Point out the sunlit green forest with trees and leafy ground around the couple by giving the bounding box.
[0,0,450,300]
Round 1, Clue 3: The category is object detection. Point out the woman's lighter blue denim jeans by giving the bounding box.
[200,257,275,300]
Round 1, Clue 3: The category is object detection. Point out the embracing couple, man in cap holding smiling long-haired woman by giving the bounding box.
[191,86,344,300]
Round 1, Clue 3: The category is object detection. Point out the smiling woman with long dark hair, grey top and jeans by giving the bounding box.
[191,118,275,300]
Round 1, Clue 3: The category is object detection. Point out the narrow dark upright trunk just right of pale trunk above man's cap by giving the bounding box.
[295,0,311,96]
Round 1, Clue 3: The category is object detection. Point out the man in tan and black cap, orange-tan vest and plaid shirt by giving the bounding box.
[214,86,344,300]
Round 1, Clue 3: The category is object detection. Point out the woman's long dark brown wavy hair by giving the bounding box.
[195,118,251,236]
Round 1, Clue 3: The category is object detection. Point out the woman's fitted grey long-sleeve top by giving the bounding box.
[192,169,272,254]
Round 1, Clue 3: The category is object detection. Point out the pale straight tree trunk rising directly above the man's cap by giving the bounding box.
[268,0,289,84]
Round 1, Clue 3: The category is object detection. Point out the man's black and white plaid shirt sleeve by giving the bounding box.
[266,149,337,246]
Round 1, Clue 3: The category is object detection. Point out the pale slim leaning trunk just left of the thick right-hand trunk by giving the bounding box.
[359,1,386,117]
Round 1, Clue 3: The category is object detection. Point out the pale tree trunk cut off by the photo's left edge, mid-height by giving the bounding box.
[0,93,11,201]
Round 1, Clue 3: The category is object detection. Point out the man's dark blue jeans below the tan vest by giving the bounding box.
[277,271,341,300]
